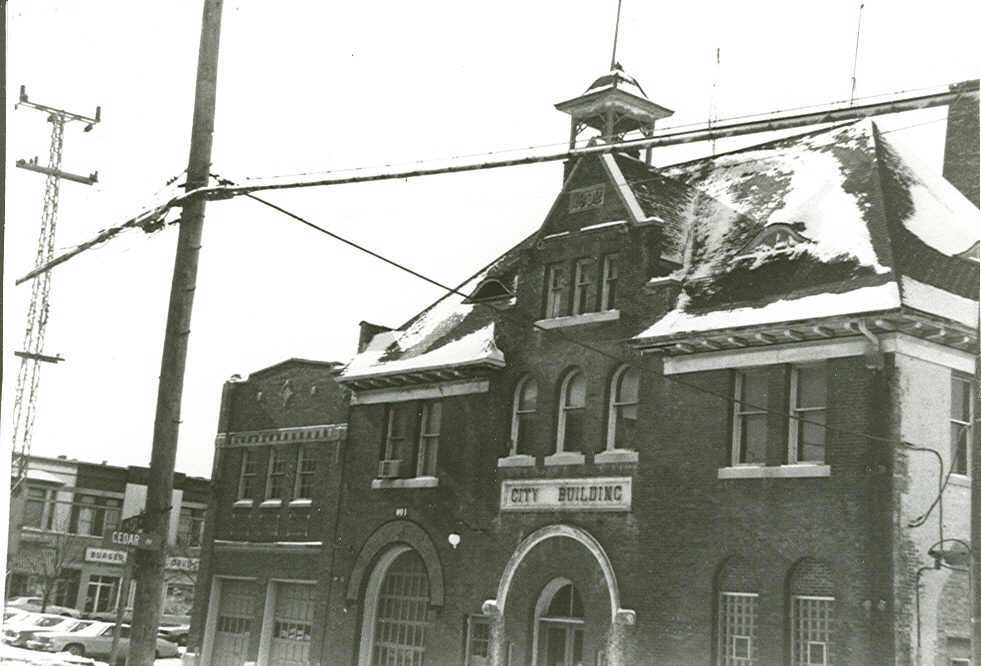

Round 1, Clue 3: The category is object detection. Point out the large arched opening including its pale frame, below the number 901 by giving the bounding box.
[358,546,429,666]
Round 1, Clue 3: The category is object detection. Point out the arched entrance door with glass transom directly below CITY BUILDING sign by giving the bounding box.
[534,578,586,666]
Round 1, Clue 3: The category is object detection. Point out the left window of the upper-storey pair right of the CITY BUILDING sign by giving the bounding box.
[731,368,769,466]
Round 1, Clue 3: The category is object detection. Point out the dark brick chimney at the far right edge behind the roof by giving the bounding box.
[944,79,981,206]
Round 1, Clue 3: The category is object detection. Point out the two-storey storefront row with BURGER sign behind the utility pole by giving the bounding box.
[7,456,211,622]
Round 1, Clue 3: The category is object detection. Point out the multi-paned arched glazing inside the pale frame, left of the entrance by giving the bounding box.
[371,550,429,666]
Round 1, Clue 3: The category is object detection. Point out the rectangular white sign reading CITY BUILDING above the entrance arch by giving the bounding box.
[501,477,631,511]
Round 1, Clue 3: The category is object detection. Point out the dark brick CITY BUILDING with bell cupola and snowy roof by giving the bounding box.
[191,69,979,666]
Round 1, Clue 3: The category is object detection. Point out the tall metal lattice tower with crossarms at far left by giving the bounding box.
[11,86,101,494]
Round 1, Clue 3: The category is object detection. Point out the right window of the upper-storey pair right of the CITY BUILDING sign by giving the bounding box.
[787,363,828,464]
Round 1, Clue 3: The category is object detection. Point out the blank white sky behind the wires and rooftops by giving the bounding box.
[0,0,981,475]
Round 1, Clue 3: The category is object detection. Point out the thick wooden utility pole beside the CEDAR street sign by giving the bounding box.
[128,0,223,666]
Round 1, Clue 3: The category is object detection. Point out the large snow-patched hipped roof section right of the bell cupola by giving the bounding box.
[634,120,981,343]
